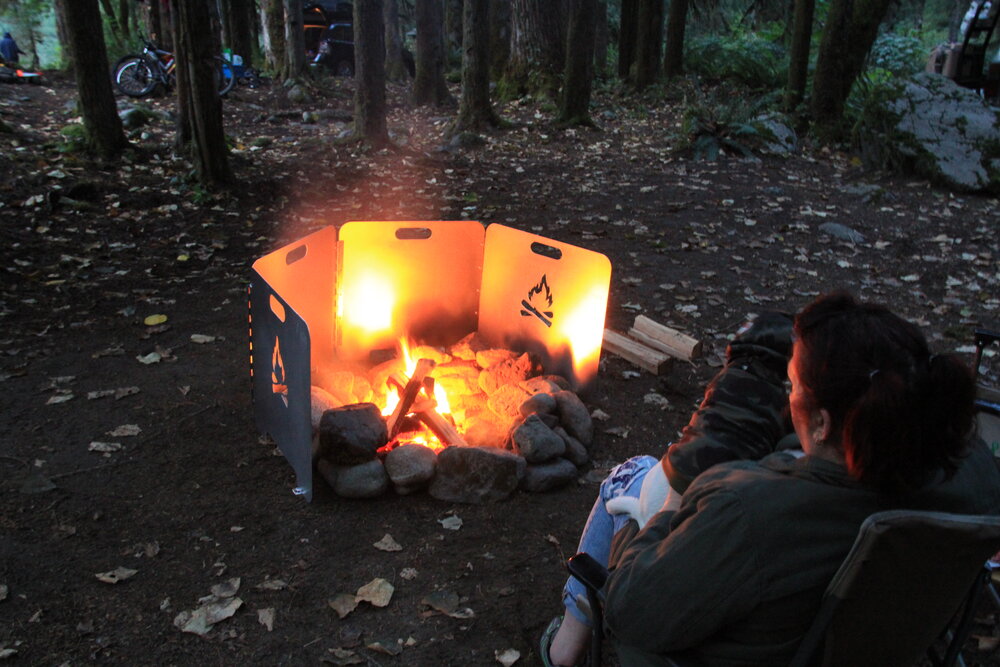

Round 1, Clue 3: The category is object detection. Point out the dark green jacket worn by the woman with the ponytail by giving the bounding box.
[605,441,1000,667]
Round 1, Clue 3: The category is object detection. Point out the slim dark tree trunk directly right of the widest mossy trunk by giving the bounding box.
[559,0,597,126]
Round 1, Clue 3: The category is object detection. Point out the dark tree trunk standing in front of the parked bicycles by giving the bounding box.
[173,0,232,188]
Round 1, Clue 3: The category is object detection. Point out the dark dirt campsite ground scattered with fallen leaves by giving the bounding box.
[0,66,1000,665]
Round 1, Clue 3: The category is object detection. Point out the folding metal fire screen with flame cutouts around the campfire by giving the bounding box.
[249,220,611,500]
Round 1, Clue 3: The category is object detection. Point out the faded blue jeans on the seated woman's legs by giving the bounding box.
[563,456,659,626]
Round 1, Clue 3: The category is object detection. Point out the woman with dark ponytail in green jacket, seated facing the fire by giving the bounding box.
[542,292,1000,666]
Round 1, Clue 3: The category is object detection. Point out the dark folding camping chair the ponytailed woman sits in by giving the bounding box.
[567,510,1000,667]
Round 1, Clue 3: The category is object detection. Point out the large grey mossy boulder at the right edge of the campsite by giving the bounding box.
[859,72,1000,192]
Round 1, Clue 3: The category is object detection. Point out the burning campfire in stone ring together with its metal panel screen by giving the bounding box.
[249,220,611,502]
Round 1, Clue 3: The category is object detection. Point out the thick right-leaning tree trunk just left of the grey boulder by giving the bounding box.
[811,0,890,138]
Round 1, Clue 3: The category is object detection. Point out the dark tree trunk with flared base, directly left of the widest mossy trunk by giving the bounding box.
[454,0,500,133]
